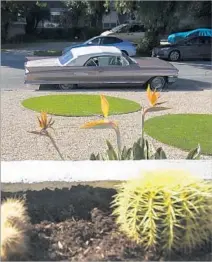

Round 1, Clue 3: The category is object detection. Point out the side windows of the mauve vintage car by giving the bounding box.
[85,56,129,66]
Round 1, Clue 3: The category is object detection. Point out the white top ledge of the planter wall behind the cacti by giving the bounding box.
[1,160,212,183]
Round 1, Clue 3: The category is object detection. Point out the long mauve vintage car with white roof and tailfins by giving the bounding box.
[25,46,178,90]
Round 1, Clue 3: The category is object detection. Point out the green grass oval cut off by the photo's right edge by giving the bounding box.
[145,114,212,155]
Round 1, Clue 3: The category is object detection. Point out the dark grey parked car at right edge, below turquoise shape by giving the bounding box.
[152,36,212,61]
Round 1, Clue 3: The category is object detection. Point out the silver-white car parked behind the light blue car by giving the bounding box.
[101,23,145,43]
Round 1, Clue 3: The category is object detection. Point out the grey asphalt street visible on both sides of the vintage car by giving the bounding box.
[1,49,212,91]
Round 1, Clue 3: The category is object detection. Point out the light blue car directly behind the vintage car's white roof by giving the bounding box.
[63,36,136,56]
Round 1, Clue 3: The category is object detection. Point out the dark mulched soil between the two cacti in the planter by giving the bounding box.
[1,184,212,261]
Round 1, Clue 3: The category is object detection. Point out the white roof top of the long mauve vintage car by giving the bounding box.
[71,46,121,58]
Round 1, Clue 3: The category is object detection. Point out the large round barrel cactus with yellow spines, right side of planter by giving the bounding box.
[112,170,212,254]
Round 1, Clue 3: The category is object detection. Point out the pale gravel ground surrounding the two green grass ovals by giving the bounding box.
[1,90,212,161]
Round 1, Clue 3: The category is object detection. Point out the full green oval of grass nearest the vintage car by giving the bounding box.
[22,94,140,116]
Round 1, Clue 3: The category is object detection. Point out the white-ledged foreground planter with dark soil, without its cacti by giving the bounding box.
[1,160,212,262]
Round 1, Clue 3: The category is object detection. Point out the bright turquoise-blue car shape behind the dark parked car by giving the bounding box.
[168,28,212,44]
